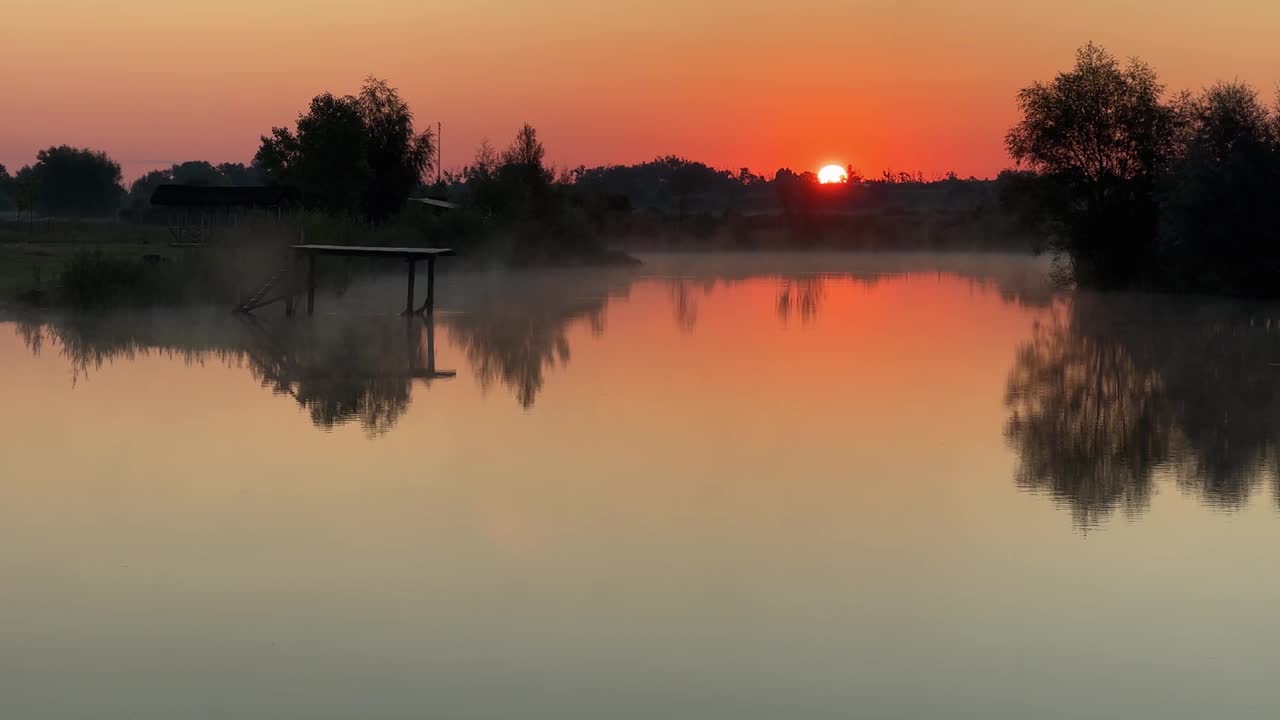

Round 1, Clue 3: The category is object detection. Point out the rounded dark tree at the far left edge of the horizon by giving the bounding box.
[19,145,124,217]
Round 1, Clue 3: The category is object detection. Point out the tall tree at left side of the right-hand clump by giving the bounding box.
[1006,44,1183,287]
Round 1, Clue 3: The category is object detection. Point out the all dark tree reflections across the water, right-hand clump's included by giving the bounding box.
[15,258,1280,528]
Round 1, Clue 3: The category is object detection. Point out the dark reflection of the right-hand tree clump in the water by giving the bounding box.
[1005,293,1280,527]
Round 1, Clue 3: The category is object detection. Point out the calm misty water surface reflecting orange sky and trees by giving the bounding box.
[0,255,1280,720]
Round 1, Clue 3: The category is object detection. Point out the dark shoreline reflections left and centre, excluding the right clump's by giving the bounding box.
[18,254,1051,436]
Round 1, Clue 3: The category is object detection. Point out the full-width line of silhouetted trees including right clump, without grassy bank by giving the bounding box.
[10,45,1280,286]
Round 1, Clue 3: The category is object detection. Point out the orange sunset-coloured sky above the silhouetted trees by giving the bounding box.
[0,0,1280,178]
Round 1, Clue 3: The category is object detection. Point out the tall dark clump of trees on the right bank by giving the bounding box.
[1006,45,1280,295]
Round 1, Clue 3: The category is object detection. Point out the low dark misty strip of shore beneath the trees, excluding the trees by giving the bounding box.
[0,206,1036,309]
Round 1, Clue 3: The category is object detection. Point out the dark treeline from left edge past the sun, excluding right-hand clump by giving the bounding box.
[0,78,1030,264]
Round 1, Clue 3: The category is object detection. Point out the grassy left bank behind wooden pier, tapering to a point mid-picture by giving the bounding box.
[0,213,637,304]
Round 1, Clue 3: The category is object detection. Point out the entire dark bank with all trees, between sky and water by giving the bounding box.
[0,45,1280,305]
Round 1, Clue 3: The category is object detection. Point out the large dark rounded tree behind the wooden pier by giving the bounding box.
[253,78,435,222]
